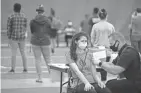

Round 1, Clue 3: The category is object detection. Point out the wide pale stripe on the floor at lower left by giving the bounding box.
[1,78,68,89]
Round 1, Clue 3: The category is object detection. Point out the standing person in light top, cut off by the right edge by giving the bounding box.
[130,8,141,53]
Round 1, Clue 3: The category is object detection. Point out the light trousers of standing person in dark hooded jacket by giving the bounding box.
[32,45,51,76]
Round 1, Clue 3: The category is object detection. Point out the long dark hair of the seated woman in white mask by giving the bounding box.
[70,32,89,62]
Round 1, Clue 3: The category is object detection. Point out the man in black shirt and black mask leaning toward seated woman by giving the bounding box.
[94,32,141,93]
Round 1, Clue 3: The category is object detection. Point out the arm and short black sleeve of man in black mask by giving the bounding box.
[96,49,134,75]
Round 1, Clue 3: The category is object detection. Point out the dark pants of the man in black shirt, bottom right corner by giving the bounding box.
[106,79,141,93]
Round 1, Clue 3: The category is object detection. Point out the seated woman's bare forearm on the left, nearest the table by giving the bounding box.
[69,63,89,84]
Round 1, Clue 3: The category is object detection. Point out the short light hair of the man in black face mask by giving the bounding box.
[109,32,126,42]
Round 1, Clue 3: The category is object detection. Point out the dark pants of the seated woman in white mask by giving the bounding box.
[76,83,112,93]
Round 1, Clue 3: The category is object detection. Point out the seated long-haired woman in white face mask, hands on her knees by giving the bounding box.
[66,32,111,93]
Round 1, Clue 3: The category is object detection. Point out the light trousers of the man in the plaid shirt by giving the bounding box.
[9,40,27,70]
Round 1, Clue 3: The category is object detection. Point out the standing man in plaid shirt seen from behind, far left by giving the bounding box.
[7,3,27,72]
